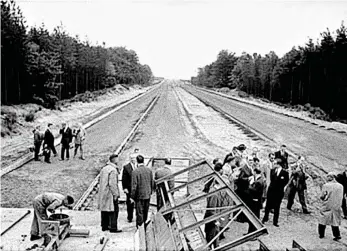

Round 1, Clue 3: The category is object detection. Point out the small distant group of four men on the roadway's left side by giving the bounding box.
[33,123,86,163]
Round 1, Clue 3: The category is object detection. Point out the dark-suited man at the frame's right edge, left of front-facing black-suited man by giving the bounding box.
[247,167,265,233]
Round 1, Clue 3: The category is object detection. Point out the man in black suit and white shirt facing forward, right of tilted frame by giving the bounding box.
[263,159,289,227]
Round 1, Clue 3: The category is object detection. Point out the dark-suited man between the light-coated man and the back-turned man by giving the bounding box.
[122,154,136,222]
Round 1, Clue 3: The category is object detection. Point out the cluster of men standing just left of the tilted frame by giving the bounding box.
[98,149,174,233]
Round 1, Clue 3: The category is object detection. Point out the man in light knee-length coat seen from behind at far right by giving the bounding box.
[318,172,343,241]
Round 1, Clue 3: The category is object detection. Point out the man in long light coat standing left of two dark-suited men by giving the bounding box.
[98,154,122,233]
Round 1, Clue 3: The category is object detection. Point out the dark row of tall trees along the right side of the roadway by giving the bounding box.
[191,22,347,120]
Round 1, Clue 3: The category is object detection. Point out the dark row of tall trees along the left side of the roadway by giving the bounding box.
[1,0,152,108]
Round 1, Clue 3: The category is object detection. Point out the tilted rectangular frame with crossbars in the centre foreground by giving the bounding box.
[156,160,268,251]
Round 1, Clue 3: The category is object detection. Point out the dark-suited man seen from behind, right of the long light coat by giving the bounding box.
[131,155,154,227]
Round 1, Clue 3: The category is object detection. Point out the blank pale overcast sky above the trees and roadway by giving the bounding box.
[16,0,347,79]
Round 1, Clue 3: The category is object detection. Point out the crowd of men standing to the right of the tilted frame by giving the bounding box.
[204,144,347,246]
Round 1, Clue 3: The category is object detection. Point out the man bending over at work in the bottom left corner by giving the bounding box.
[30,193,74,241]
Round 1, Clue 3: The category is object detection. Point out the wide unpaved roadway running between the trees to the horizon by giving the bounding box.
[1,81,347,250]
